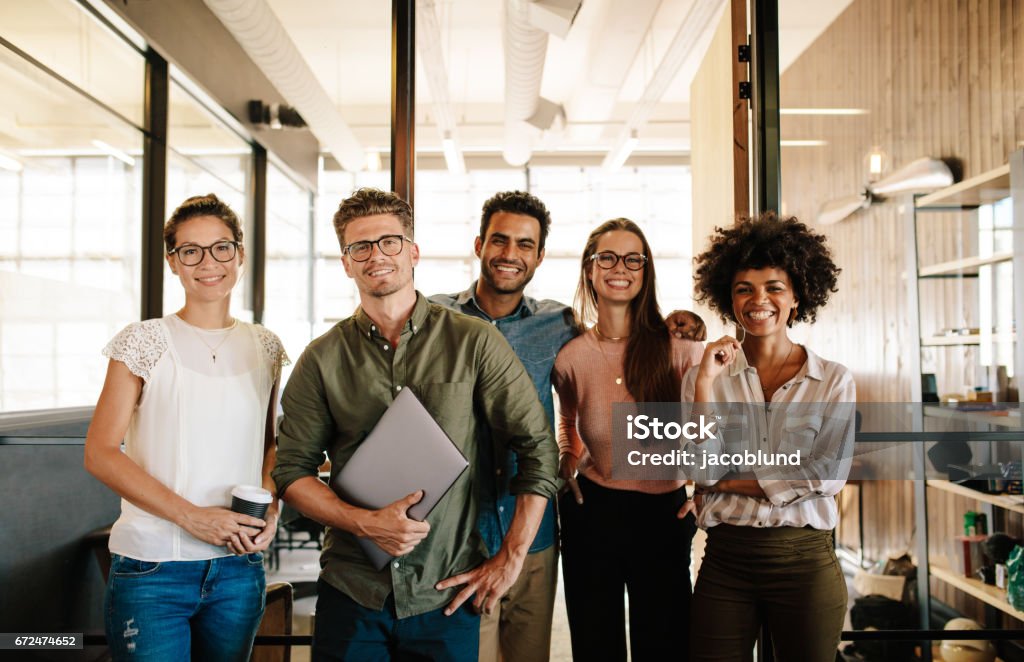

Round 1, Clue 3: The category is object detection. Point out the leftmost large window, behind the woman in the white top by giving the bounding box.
[0,2,143,411]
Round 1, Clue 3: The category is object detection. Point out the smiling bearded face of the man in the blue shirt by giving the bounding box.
[475,211,544,294]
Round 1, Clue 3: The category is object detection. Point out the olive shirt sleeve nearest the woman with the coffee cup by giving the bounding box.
[271,350,335,495]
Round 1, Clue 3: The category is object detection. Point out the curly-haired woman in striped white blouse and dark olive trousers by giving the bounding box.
[682,214,856,662]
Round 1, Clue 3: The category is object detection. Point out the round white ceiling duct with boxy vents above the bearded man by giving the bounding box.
[502,0,583,166]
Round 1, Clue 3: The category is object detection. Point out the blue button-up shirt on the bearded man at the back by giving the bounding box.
[430,282,577,554]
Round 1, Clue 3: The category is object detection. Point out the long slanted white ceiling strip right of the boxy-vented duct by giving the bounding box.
[601,0,724,170]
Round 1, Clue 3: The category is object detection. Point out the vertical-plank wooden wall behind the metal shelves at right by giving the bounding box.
[780,0,1024,627]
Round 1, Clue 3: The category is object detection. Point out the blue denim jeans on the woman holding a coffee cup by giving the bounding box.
[103,553,266,662]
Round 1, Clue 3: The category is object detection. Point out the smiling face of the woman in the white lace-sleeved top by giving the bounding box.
[167,216,244,301]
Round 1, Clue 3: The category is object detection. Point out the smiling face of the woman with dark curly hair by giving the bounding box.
[732,266,800,336]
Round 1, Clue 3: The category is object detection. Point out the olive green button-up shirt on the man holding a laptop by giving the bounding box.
[273,292,558,618]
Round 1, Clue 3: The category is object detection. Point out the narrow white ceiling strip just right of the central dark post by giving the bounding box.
[416,0,466,174]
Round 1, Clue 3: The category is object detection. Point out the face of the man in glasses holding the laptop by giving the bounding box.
[341,214,420,298]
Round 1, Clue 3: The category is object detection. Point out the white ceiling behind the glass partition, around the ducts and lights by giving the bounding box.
[268,0,851,160]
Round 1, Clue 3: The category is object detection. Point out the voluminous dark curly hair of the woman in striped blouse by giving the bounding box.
[693,212,842,326]
